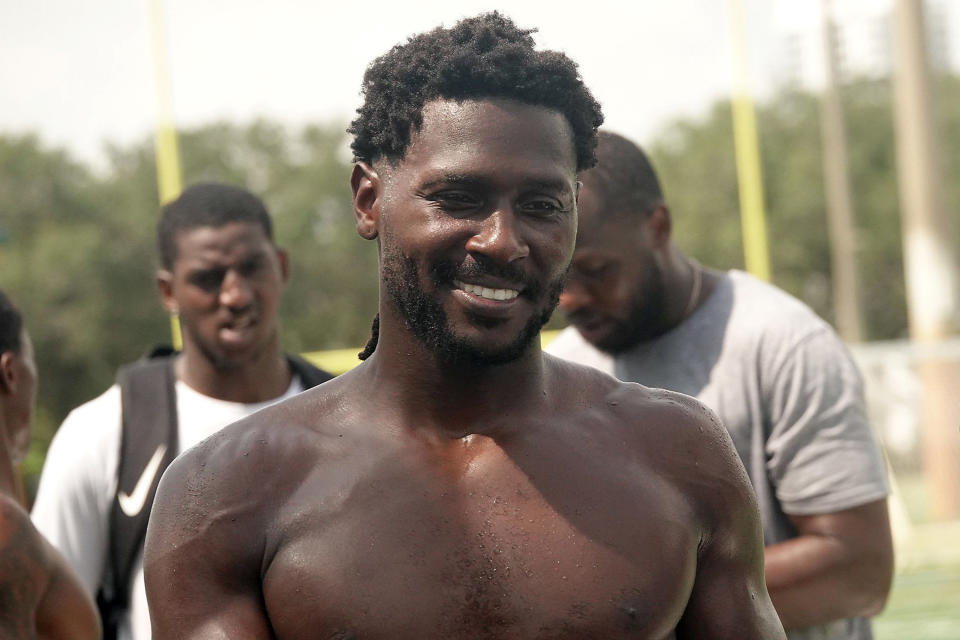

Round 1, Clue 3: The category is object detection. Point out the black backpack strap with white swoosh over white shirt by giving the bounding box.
[97,357,178,640]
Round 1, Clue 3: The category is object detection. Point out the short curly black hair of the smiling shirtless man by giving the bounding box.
[347,12,603,171]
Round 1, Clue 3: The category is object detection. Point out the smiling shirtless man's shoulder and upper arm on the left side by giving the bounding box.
[144,370,376,639]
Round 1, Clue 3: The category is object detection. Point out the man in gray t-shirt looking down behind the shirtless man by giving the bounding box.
[547,132,893,640]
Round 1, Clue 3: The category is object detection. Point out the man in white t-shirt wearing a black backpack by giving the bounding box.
[32,183,330,640]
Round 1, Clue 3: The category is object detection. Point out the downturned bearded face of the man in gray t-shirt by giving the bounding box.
[560,178,666,353]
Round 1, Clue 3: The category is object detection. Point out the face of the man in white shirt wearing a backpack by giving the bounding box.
[157,222,287,369]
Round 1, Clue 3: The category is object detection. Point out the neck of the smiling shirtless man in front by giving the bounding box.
[363,310,546,438]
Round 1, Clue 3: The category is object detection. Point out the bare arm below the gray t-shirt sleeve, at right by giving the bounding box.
[766,500,893,629]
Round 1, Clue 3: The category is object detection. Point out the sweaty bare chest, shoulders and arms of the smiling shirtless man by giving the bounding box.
[146,359,782,640]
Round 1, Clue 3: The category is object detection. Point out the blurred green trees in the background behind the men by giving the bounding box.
[0,77,960,496]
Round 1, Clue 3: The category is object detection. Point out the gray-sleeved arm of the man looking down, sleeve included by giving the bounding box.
[765,328,893,629]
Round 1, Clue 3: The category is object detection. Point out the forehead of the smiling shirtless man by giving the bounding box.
[399,99,576,184]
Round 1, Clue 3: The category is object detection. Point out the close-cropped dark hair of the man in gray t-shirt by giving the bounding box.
[583,130,663,216]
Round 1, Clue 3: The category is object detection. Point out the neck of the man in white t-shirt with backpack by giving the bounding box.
[174,336,291,404]
